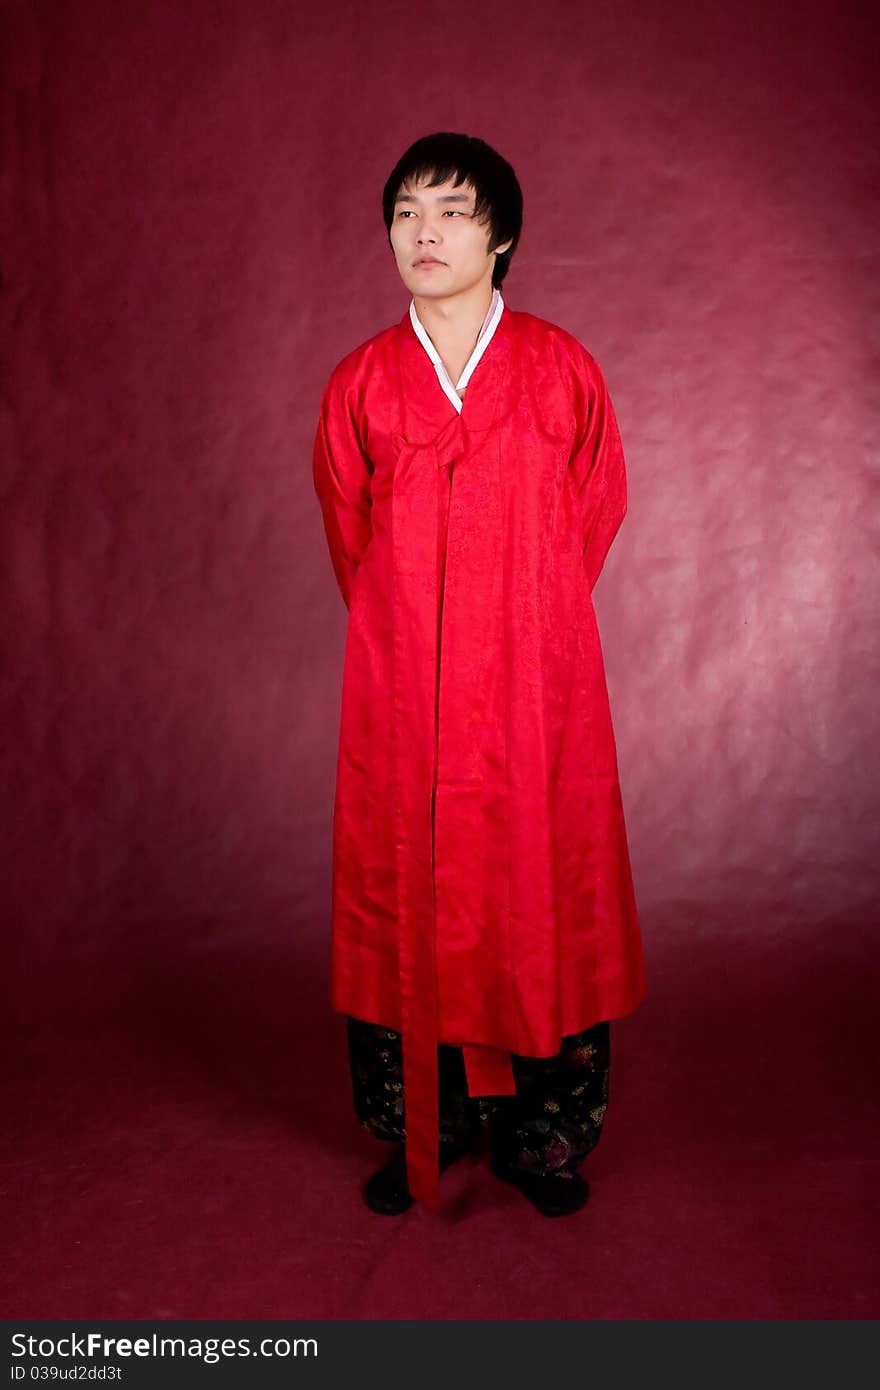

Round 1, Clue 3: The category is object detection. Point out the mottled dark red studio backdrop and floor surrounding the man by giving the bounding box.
[0,0,880,1318]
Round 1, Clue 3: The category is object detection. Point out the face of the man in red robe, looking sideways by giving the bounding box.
[391,173,512,299]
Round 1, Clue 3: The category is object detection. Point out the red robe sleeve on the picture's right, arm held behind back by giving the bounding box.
[569,349,627,592]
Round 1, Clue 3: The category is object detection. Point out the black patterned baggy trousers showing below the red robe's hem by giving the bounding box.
[348,1017,610,1175]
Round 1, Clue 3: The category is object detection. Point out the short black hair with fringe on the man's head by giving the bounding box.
[382,131,523,288]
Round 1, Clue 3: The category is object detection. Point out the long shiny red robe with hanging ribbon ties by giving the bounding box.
[313,304,645,1207]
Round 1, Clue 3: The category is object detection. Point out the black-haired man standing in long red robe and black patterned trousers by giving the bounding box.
[313,132,645,1216]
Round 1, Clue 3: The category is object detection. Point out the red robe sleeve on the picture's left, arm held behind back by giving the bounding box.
[311,368,373,609]
